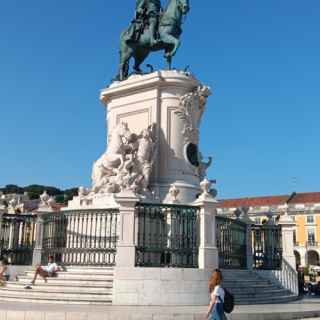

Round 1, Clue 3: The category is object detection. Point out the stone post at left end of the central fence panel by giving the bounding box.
[116,191,139,268]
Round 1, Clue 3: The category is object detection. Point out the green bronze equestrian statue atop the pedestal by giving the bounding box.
[117,0,190,81]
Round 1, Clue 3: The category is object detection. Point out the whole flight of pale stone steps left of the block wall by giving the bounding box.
[0,266,114,305]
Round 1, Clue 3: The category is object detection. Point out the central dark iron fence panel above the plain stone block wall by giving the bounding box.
[135,204,199,268]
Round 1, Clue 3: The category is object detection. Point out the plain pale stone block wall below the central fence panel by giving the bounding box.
[113,267,211,306]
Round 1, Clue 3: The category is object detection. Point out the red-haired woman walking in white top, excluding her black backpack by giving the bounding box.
[207,270,226,320]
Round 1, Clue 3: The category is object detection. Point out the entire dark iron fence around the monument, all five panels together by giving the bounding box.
[0,203,282,270]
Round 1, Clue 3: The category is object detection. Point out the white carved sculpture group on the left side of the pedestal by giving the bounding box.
[92,123,155,194]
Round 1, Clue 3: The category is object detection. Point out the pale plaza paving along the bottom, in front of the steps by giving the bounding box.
[0,299,320,320]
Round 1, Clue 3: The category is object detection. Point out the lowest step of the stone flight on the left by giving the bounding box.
[0,287,112,301]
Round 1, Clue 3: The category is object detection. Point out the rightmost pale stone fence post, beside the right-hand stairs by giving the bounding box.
[279,207,296,270]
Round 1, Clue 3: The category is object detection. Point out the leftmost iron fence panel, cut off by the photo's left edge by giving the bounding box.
[0,214,37,265]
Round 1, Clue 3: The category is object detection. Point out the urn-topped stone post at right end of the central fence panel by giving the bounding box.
[193,179,219,270]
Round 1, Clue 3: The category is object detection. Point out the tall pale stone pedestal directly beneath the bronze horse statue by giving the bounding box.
[101,71,210,203]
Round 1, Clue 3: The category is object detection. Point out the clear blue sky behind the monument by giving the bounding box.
[0,0,320,198]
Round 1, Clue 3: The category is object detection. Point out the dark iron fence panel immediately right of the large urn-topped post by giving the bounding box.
[216,216,247,269]
